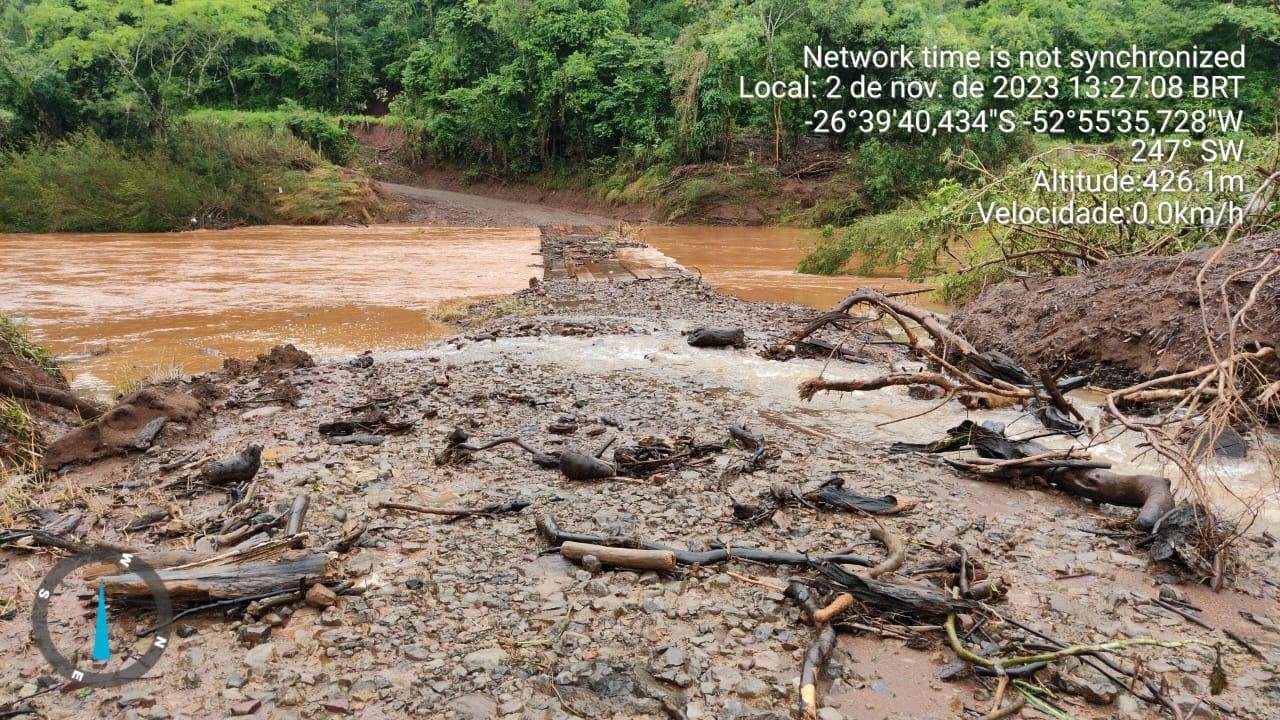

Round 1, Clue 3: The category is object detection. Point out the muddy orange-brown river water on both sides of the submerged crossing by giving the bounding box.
[0,225,925,395]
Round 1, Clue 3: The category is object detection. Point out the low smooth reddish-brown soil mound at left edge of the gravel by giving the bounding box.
[44,386,205,470]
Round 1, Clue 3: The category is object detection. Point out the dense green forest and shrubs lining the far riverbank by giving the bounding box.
[0,0,1280,283]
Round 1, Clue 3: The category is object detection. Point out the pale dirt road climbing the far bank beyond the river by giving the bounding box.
[381,182,613,227]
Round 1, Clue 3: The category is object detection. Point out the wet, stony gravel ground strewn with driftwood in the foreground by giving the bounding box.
[0,229,1280,720]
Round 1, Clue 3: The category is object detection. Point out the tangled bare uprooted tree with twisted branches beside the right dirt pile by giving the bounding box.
[788,228,1280,588]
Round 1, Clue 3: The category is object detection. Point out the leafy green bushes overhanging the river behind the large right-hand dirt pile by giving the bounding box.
[796,135,1280,304]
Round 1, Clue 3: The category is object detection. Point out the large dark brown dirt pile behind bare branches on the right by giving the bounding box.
[952,233,1280,383]
